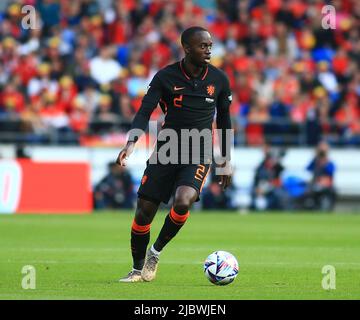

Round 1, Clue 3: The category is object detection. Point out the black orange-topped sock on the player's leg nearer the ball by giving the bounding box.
[154,208,190,252]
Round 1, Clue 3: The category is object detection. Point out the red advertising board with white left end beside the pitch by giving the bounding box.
[0,160,93,214]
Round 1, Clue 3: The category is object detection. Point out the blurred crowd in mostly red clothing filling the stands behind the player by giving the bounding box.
[0,0,360,145]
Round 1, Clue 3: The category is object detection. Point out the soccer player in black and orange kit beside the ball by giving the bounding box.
[116,27,232,282]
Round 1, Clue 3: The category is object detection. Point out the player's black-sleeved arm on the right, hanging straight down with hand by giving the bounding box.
[216,74,232,190]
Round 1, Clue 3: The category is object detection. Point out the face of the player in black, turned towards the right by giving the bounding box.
[186,31,212,66]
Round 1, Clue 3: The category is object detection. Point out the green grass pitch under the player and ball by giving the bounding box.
[0,211,360,300]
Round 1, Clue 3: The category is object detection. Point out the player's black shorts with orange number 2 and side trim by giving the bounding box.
[138,162,211,204]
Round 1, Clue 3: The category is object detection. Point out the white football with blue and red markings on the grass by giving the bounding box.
[204,251,239,286]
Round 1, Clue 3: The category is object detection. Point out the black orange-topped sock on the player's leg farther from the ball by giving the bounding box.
[131,219,150,270]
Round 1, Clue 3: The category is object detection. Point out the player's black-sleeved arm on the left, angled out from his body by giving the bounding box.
[116,72,162,166]
